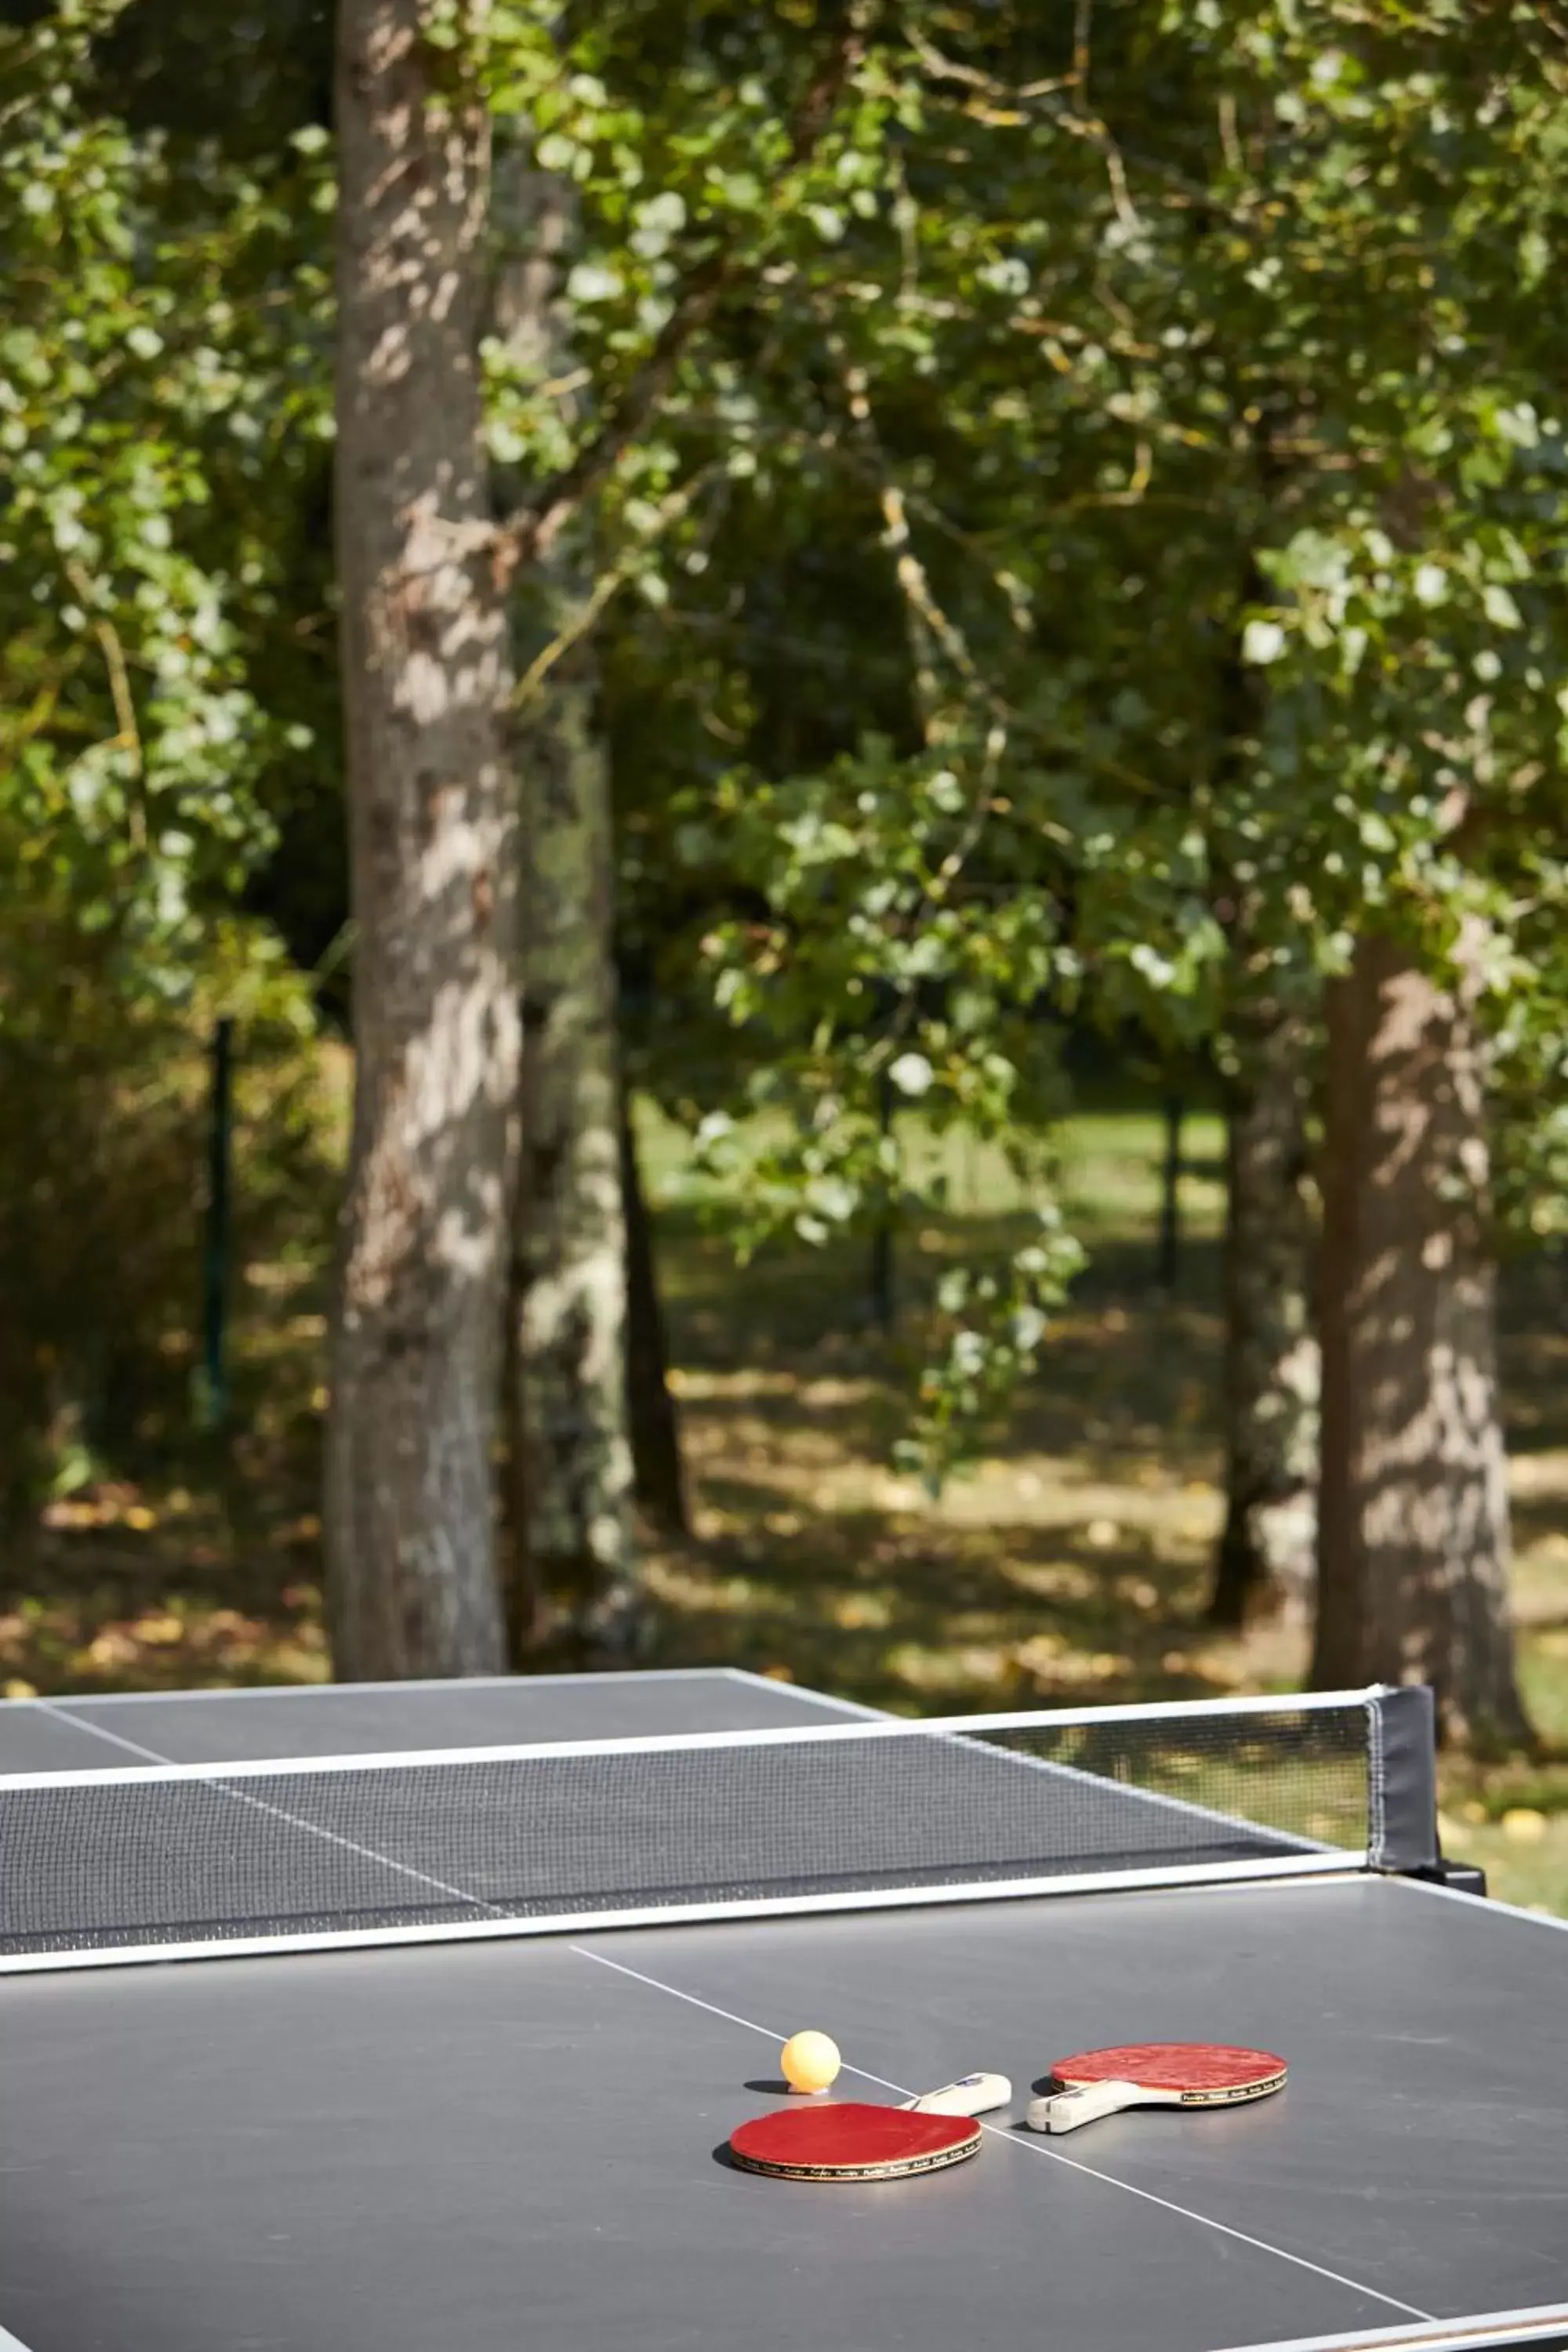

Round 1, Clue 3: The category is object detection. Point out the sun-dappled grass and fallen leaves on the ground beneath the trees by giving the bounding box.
[0,1112,1568,1915]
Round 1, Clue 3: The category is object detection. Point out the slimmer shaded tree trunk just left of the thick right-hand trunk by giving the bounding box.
[1208,1007,1319,1630]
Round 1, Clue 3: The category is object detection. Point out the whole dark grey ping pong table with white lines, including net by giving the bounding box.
[0,1672,1568,2352]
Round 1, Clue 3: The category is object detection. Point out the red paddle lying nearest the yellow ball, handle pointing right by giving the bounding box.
[729,2074,1013,2180]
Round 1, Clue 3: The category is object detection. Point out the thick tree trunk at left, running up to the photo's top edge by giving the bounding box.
[327,0,517,1677]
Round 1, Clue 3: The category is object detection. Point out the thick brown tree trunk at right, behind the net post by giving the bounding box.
[1312,936,1526,1740]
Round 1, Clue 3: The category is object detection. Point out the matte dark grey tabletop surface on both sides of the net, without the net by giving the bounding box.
[0,1675,1568,2352]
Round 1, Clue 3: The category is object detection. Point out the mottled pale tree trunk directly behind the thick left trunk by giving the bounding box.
[499,160,642,1663]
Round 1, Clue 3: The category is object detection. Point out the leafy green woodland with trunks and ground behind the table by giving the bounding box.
[0,0,1568,1907]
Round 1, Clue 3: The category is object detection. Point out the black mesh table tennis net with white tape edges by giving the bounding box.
[0,1693,1425,1971]
